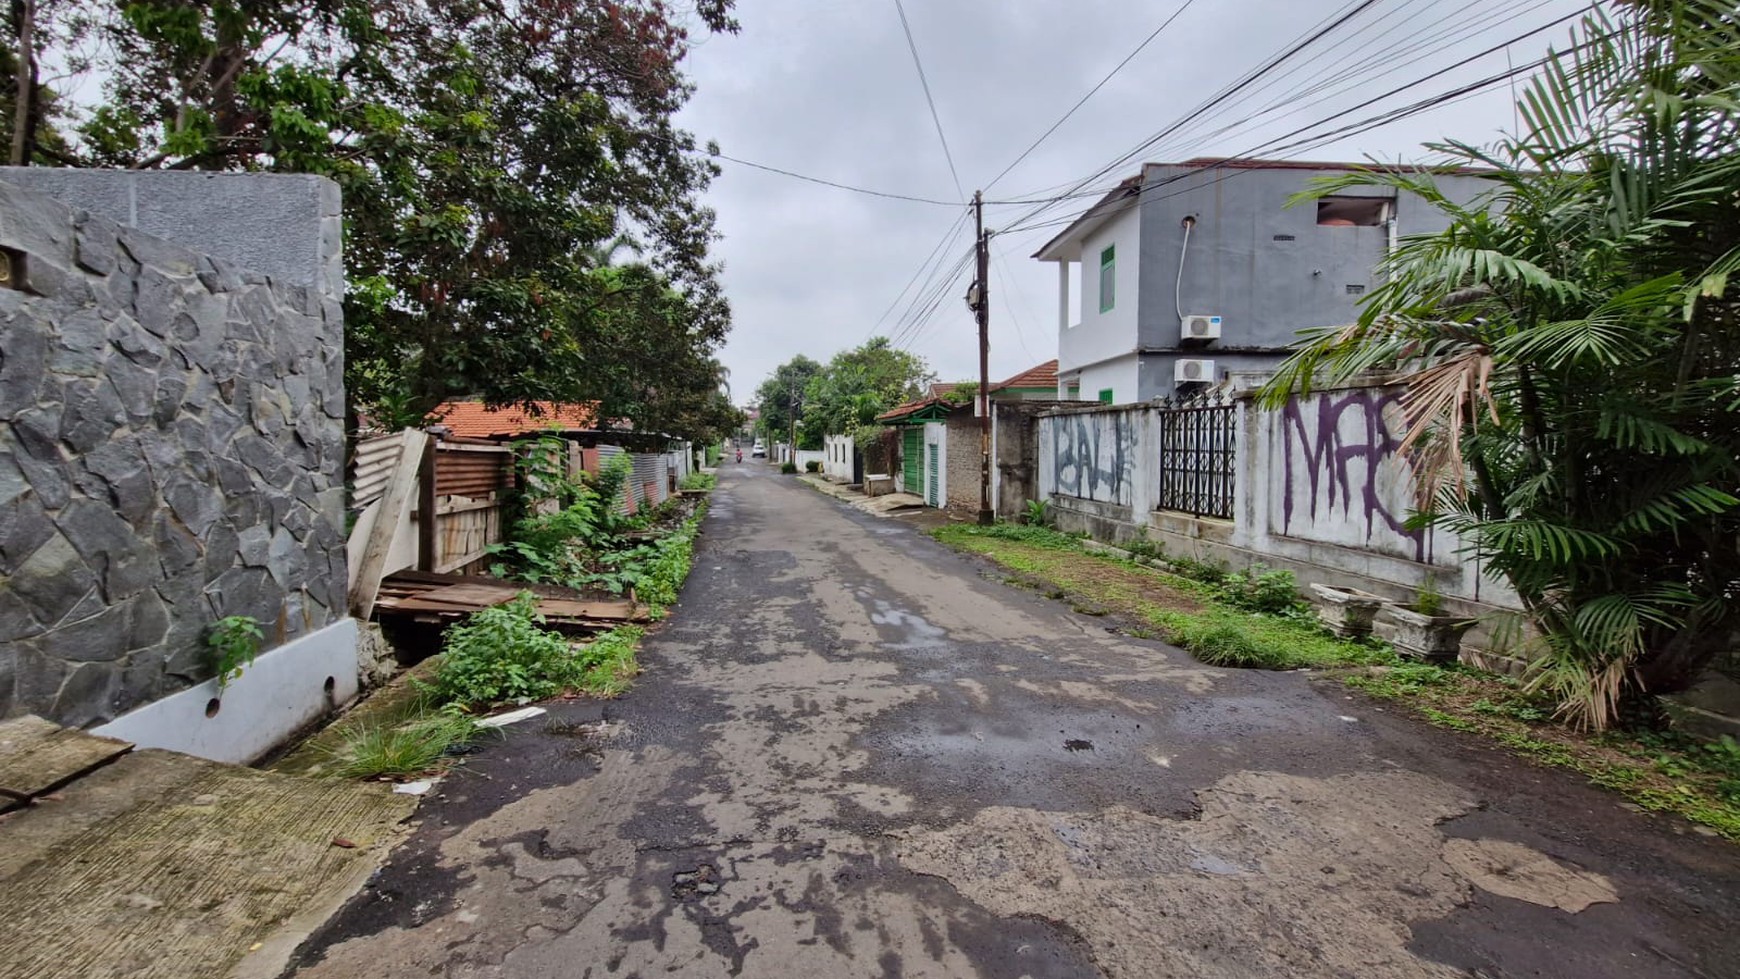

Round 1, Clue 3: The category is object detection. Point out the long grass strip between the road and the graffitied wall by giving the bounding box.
[933,523,1740,842]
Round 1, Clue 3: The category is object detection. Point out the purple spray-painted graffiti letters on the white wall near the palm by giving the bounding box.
[1281,391,1430,562]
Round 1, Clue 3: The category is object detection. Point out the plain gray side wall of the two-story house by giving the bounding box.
[1127,163,1488,400]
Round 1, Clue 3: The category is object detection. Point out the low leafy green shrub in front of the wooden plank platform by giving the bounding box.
[432,591,605,706]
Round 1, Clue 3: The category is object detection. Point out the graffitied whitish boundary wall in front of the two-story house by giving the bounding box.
[1034,387,1517,609]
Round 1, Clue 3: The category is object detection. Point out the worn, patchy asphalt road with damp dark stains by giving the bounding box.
[292,463,1740,979]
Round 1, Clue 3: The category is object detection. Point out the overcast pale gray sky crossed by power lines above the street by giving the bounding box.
[680,0,1587,402]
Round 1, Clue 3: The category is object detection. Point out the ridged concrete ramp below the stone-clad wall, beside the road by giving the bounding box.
[0,749,416,979]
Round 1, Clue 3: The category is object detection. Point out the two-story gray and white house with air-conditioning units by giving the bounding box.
[1034,160,1486,403]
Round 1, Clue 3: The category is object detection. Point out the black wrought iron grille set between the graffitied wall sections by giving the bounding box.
[1157,398,1237,520]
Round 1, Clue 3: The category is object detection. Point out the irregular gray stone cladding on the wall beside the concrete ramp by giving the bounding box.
[0,177,345,727]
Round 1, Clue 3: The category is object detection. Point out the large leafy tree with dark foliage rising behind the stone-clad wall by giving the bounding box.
[3,0,736,439]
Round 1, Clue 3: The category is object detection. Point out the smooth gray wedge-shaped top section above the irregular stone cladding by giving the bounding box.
[0,167,345,299]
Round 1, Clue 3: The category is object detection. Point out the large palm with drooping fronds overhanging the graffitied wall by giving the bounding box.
[1268,0,1740,727]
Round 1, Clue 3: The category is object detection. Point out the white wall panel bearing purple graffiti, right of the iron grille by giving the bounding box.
[1279,388,1432,562]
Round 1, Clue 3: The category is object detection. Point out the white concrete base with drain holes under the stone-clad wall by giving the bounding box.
[92,619,357,765]
